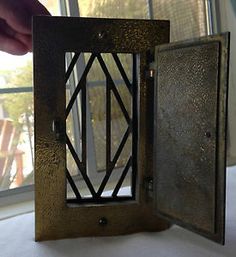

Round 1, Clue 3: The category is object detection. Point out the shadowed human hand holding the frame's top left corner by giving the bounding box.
[0,0,50,55]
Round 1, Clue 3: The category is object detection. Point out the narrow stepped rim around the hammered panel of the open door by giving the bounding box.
[154,32,230,245]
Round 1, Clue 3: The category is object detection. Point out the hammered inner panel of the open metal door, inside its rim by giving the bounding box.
[157,43,219,232]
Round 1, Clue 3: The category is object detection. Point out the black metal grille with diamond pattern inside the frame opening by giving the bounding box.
[65,53,137,203]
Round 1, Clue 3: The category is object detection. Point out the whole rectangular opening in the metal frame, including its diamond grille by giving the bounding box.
[65,52,138,203]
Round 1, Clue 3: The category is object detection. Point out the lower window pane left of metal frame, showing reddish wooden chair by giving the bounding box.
[0,93,34,190]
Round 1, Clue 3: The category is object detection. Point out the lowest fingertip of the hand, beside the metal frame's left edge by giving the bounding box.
[0,34,28,55]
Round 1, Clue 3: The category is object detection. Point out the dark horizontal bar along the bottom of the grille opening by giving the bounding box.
[67,196,133,204]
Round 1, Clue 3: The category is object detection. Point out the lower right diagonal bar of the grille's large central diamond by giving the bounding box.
[97,127,130,197]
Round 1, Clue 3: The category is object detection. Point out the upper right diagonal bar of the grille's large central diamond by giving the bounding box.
[97,54,130,124]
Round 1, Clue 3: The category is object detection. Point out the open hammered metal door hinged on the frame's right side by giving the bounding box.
[154,33,229,244]
